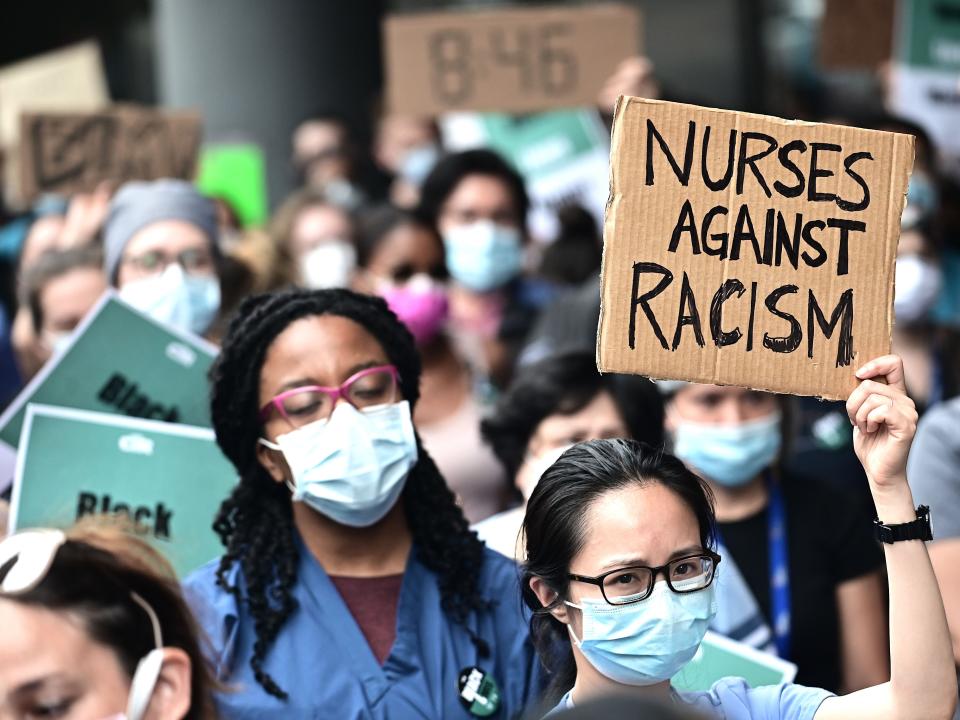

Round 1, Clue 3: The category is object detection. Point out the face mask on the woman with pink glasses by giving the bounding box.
[260,400,417,527]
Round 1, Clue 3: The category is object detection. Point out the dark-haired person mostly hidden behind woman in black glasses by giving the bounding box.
[474,353,663,561]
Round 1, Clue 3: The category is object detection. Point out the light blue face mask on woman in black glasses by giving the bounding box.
[567,581,717,685]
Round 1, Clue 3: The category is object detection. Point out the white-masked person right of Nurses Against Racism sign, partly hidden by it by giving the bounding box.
[893,222,960,413]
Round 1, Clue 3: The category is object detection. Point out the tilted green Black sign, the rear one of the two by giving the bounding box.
[0,290,217,491]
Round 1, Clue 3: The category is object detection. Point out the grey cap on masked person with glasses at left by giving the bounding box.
[103,180,219,284]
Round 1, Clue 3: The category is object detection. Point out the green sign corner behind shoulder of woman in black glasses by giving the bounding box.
[670,632,797,692]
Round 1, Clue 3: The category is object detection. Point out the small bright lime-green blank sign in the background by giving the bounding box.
[197,143,268,227]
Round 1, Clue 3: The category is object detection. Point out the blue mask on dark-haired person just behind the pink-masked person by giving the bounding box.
[443,220,523,292]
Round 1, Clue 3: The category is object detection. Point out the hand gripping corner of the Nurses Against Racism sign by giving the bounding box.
[847,355,918,488]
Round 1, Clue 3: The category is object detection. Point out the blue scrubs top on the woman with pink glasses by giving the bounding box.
[184,542,543,720]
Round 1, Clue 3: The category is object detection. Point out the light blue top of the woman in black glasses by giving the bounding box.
[547,677,833,720]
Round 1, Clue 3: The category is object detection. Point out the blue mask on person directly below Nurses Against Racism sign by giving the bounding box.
[673,411,782,487]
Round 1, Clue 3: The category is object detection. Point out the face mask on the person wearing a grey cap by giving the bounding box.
[120,263,220,335]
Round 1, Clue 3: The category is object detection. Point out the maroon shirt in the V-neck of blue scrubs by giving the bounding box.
[330,574,403,665]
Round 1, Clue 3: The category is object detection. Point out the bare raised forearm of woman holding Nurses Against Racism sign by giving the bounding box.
[871,482,957,719]
